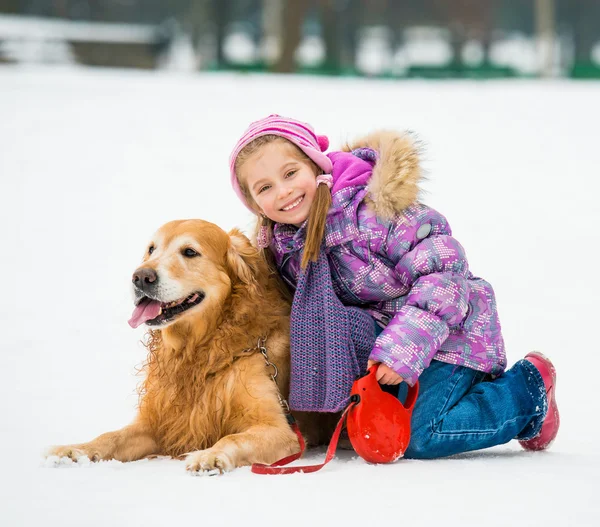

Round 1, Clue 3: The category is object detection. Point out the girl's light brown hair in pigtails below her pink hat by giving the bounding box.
[235,134,331,270]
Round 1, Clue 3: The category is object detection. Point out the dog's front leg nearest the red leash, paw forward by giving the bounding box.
[186,423,300,475]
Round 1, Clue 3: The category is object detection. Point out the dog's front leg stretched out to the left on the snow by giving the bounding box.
[46,421,158,461]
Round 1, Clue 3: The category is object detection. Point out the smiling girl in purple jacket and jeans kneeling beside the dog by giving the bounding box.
[230,115,559,458]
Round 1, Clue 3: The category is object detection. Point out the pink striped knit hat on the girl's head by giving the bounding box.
[229,114,332,212]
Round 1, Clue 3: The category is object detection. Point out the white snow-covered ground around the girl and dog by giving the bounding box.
[0,67,600,527]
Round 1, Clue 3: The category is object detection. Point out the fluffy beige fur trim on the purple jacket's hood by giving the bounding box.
[342,130,423,223]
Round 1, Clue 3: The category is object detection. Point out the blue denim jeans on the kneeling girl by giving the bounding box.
[376,322,548,459]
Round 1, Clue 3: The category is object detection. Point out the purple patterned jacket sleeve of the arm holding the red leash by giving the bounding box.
[370,228,469,385]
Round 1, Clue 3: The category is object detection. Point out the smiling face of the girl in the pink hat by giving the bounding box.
[240,141,317,227]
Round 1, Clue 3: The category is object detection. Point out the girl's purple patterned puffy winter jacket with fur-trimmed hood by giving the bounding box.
[270,132,506,385]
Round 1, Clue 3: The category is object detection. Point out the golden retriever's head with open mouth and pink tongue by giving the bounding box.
[129,220,255,328]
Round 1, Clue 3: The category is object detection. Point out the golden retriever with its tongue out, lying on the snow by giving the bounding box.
[48,220,314,474]
